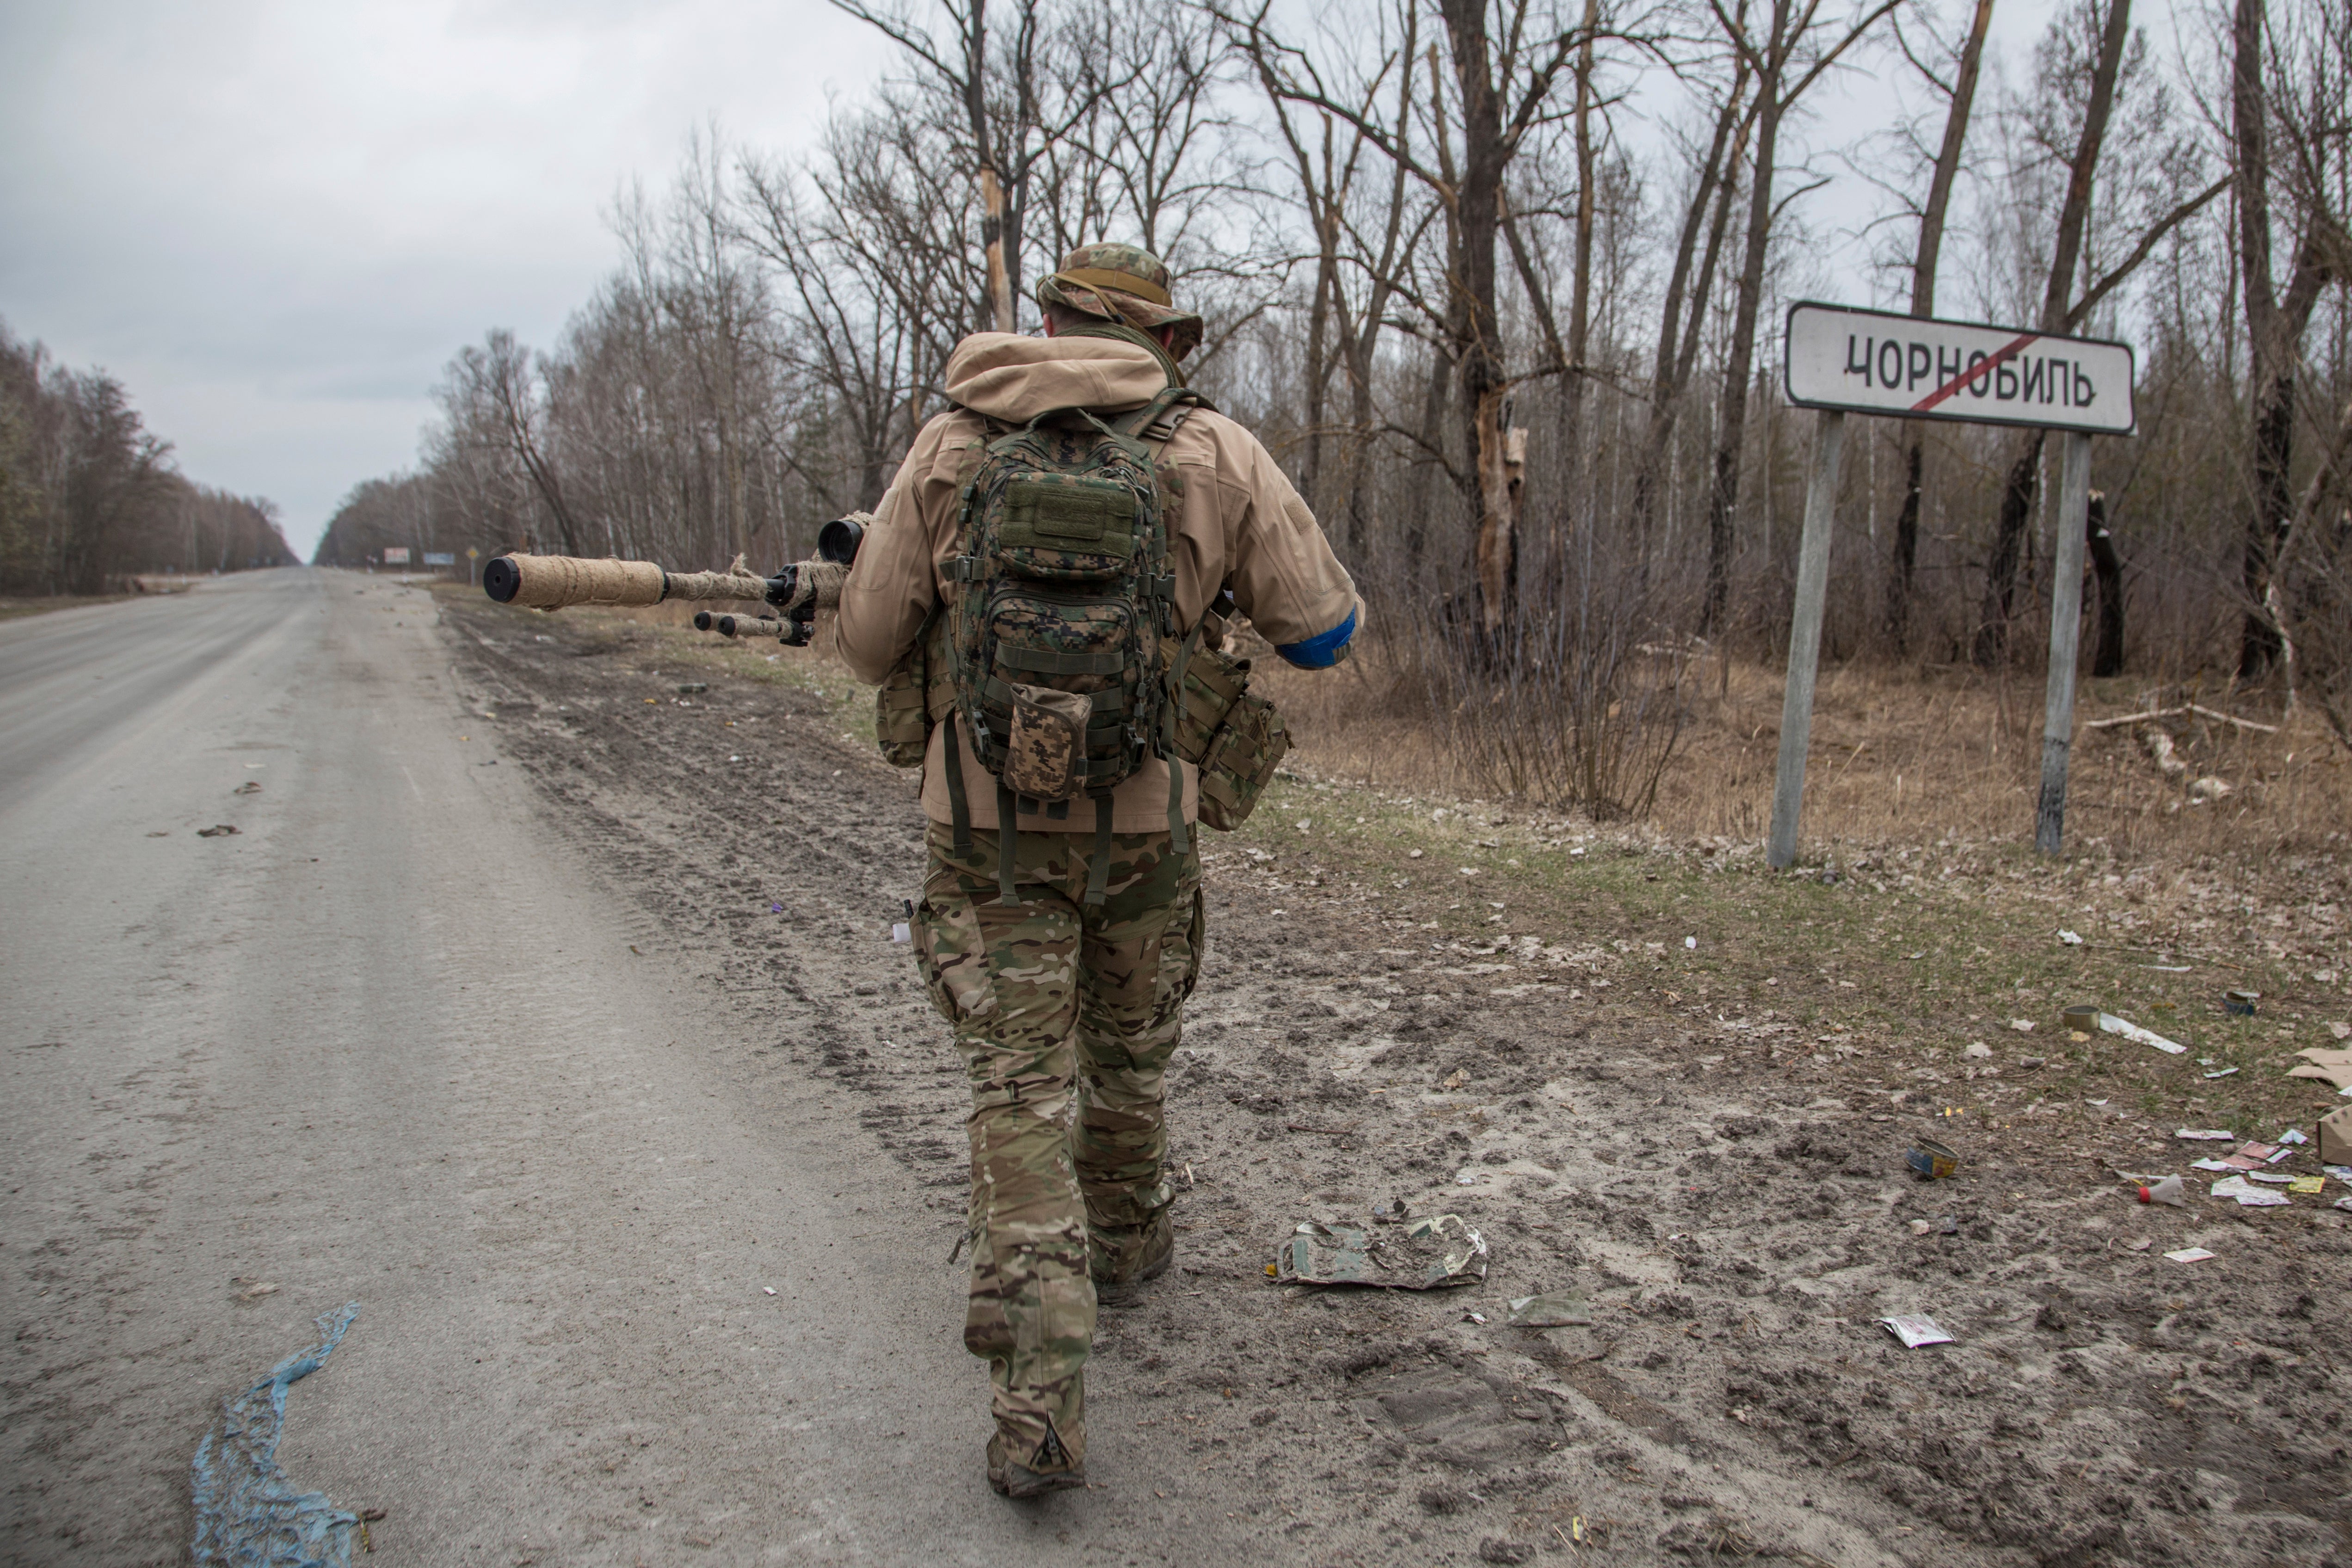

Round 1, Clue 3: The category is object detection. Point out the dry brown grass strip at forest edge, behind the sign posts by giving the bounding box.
[1254,651,2352,867]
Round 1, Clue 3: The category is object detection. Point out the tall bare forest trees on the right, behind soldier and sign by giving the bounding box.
[320,0,2352,809]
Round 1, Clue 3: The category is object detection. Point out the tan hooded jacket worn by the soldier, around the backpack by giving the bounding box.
[832,332,1362,832]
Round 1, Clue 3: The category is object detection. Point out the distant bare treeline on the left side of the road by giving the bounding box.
[0,322,299,595]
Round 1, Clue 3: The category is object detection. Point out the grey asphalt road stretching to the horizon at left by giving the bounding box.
[0,569,1213,1568]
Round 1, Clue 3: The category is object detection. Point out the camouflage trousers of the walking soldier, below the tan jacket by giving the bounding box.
[915,823,1202,1472]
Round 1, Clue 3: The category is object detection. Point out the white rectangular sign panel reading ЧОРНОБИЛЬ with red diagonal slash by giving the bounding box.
[1787,301,2136,435]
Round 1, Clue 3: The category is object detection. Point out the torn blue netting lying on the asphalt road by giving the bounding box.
[195,1303,360,1568]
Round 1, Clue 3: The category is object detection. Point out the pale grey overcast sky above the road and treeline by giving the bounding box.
[0,0,2088,555]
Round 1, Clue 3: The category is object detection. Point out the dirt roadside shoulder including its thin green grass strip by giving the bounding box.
[437,595,2352,1568]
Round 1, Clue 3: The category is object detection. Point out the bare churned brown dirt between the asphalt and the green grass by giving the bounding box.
[428,592,2352,1566]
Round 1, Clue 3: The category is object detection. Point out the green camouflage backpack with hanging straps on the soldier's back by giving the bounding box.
[946,386,1207,903]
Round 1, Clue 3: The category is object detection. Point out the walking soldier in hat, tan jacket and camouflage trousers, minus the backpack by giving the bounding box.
[835,245,1362,1497]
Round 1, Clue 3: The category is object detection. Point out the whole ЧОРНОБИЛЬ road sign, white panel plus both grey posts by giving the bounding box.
[1764,301,2138,867]
